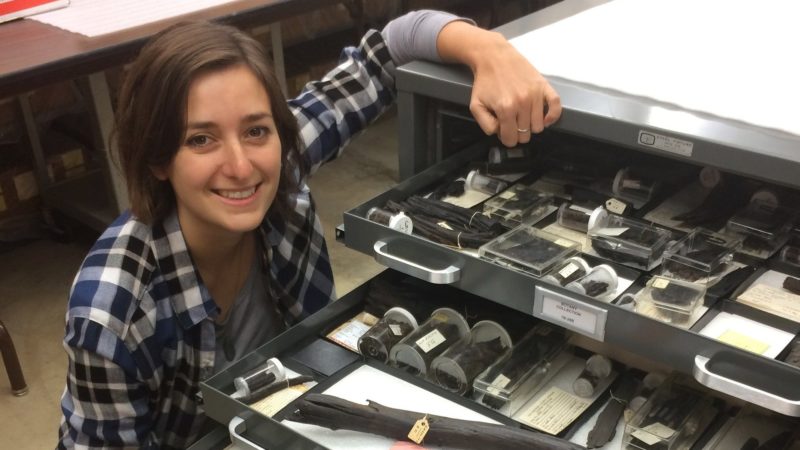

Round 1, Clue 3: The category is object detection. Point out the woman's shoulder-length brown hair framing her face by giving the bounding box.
[113,22,307,224]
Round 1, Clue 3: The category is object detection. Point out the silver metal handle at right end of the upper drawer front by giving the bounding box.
[693,355,800,417]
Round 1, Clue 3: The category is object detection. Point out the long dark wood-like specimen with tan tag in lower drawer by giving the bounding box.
[288,394,585,450]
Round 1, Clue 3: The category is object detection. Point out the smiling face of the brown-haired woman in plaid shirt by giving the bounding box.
[154,65,281,237]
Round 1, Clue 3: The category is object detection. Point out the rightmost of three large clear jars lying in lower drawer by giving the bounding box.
[431,320,513,395]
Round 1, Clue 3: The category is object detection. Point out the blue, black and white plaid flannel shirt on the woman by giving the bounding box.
[58,31,394,449]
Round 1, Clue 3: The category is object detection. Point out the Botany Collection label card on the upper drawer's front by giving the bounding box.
[533,286,607,341]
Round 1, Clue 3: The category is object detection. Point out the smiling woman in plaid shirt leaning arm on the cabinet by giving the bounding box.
[59,11,560,449]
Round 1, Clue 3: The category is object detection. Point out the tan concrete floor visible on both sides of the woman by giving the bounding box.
[0,108,397,449]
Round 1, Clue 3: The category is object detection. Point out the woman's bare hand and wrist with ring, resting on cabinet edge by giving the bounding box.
[437,21,561,147]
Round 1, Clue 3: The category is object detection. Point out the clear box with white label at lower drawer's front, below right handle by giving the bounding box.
[622,381,717,450]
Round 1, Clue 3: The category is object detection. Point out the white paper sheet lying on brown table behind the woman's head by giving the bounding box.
[30,0,241,37]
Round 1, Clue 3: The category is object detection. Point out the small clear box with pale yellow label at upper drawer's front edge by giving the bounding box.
[636,276,706,325]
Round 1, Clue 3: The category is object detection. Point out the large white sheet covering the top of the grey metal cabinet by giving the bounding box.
[512,0,800,135]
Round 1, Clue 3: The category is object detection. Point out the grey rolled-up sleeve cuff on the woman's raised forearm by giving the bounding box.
[381,10,475,66]
